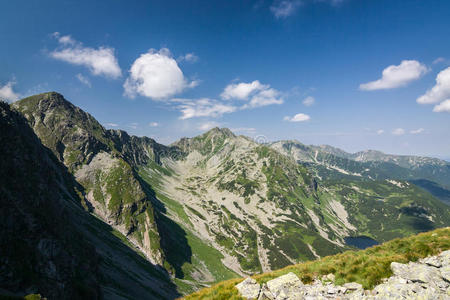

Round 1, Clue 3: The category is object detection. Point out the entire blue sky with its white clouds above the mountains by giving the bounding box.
[0,0,450,158]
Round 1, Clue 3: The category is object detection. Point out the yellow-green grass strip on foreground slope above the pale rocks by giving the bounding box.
[184,227,450,300]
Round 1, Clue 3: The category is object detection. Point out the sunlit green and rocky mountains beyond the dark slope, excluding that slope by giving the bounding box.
[3,93,450,293]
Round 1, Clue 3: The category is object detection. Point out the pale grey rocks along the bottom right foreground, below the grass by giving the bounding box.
[236,250,450,300]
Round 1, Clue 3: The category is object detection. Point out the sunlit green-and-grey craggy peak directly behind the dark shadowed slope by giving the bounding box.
[14,92,165,265]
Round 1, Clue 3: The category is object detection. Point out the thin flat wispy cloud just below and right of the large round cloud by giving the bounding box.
[173,98,236,120]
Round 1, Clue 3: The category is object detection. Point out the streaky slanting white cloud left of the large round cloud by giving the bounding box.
[50,33,122,78]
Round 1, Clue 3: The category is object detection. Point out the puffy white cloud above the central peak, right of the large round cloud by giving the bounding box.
[220,80,284,109]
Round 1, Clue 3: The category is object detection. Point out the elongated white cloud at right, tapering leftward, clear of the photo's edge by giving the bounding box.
[359,60,428,91]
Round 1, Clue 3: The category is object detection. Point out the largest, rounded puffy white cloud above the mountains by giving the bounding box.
[123,48,198,100]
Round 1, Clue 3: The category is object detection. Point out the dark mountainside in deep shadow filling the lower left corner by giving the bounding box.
[0,102,179,299]
